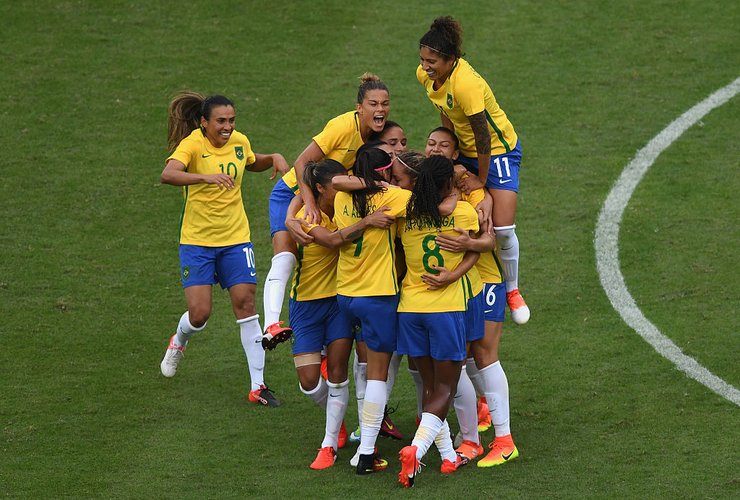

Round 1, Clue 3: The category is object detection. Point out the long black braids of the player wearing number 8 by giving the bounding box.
[406,155,454,228]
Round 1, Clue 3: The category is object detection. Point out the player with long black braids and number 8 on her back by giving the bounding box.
[398,156,479,487]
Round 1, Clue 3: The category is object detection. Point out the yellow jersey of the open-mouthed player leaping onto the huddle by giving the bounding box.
[283,111,364,193]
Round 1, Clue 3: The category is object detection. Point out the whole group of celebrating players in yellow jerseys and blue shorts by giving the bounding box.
[161,16,530,487]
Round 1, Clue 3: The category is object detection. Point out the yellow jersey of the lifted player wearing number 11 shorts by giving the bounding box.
[416,58,517,158]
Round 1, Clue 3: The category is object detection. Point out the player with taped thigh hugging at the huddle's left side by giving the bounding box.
[286,159,394,470]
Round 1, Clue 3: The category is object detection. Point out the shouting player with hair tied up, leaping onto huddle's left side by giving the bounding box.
[263,73,390,349]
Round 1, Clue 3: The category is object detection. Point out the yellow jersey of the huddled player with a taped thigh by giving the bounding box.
[290,208,339,301]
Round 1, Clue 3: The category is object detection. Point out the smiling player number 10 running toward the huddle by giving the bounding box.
[160,92,289,406]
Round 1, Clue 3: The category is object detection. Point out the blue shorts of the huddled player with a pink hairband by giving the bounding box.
[337,295,398,352]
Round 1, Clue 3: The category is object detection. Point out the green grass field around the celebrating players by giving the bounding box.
[0,0,740,498]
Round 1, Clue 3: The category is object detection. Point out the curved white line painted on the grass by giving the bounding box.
[594,78,740,406]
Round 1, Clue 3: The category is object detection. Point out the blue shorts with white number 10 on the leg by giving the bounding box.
[180,243,257,288]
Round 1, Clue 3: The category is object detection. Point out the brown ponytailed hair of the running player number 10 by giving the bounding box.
[167,90,234,153]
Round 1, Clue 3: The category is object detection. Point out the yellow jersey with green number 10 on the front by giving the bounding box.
[167,128,256,247]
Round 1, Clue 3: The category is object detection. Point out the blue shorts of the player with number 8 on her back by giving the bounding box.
[398,311,466,361]
